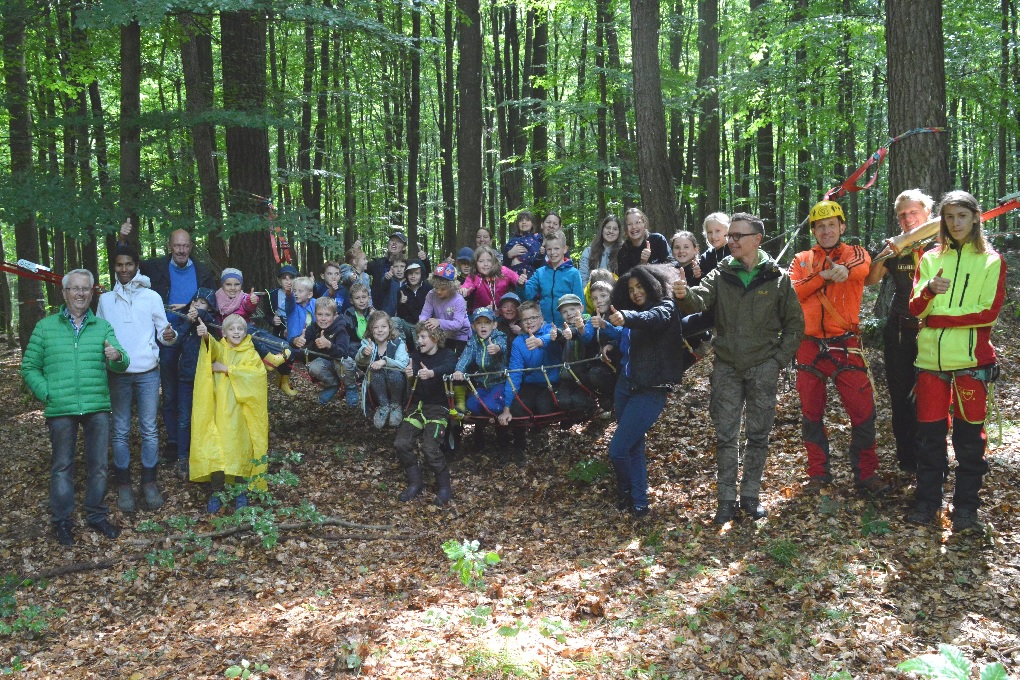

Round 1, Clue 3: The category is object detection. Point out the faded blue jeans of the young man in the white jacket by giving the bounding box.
[109,368,159,470]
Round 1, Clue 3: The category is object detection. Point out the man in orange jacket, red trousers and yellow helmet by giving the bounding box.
[789,201,888,496]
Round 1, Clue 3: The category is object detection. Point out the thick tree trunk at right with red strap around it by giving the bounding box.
[885,0,950,221]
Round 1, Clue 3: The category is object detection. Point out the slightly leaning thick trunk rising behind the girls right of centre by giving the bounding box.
[630,0,676,233]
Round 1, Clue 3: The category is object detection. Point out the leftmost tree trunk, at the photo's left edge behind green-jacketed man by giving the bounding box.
[0,0,46,352]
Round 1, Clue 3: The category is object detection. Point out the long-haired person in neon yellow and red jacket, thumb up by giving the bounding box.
[907,191,1006,532]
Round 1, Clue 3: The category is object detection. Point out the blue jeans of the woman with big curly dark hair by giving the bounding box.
[609,375,666,510]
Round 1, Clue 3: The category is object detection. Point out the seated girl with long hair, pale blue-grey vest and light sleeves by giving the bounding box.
[355,309,408,430]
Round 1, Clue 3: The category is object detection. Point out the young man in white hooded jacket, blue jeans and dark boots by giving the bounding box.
[96,246,177,513]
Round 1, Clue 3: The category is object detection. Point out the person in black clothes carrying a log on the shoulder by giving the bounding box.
[864,189,934,472]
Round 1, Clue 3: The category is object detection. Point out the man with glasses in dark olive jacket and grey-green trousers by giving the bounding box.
[673,212,804,524]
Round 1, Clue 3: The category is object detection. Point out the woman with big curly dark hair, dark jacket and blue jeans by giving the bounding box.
[606,265,683,519]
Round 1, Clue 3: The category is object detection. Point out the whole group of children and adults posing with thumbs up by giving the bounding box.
[22,191,1005,544]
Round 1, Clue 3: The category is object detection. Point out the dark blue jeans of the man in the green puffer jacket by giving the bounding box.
[46,411,110,522]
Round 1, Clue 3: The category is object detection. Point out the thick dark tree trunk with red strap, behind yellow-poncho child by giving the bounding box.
[219,11,276,290]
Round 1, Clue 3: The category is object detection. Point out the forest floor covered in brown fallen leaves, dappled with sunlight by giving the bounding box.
[0,257,1020,680]
